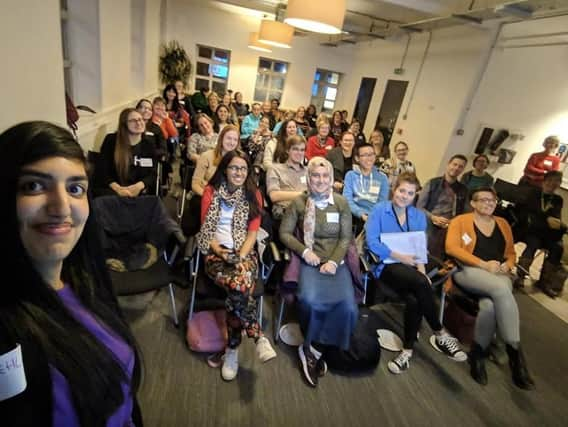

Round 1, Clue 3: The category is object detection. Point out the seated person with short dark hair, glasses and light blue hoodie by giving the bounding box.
[343,143,389,228]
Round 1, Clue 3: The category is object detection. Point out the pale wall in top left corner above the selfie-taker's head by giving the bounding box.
[0,0,66,132]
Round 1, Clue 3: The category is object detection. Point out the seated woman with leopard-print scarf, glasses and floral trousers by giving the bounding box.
[197,150,276,381]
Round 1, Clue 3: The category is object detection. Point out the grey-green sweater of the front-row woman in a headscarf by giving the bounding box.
[280,194,352,265]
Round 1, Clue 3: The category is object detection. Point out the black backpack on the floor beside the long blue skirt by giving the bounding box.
[325,308,381,373]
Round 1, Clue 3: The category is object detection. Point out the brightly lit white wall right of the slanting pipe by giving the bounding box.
[451,17,568,186]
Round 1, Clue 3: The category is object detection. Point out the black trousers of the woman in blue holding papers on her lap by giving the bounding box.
[380,263,442,349]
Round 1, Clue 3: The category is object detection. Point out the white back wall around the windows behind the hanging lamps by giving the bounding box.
[163,0,353,109]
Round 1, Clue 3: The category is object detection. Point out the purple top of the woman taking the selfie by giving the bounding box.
[50,285,134,427]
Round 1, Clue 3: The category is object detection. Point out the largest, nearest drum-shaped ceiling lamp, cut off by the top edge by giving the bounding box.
[284,0,347,34]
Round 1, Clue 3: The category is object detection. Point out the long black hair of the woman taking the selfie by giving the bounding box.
[0,121,140,427]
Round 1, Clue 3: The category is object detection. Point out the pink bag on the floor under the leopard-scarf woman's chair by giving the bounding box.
[186,310,227,353]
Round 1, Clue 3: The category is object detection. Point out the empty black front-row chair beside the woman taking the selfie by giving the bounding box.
[93,196,186,326]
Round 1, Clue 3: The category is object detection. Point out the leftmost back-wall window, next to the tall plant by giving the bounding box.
[195,45,231,96]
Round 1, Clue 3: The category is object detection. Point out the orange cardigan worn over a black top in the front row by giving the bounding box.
[446,213,517,289]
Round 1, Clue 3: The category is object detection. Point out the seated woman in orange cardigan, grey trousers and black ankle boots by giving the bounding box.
[446,187,534,390]
